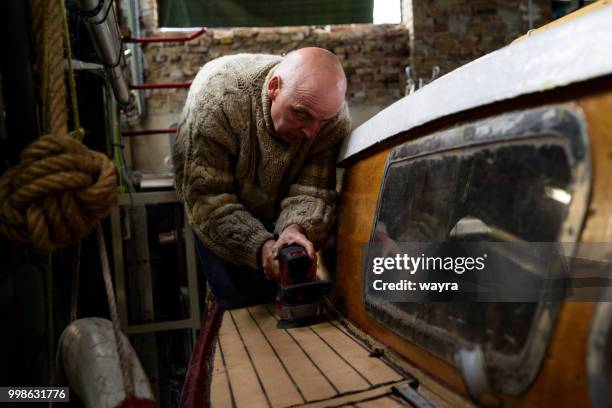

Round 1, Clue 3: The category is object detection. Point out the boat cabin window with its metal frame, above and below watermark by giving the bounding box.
[364,105,590,394]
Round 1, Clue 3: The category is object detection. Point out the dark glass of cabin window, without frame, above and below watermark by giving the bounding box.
[378,141,571,353]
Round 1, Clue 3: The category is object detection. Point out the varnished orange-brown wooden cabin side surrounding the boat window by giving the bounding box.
[333,83,612,407]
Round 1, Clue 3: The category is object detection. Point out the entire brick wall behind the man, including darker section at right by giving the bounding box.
[123,0,551,173]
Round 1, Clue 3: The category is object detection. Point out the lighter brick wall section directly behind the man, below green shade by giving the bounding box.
[144,24,410,114]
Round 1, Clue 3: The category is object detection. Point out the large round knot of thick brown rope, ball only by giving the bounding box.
[0,135,117,251]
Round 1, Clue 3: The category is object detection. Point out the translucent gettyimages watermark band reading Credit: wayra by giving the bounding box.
[364,242,612,302]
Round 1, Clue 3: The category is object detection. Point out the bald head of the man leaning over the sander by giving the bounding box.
[268,47,346,143]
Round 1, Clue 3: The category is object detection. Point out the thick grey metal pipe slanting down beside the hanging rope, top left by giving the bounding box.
[75,0,133,106]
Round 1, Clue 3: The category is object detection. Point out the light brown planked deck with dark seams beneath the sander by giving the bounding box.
[211,306,406,408]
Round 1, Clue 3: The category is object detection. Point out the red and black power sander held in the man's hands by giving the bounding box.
[276,245,331,329]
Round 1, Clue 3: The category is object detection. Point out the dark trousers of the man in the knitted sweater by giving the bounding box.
[195,236,277,310]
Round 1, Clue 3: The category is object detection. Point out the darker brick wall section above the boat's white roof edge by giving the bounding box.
[402,0,552,78]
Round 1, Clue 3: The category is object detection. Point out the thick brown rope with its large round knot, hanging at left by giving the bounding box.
[0,0,118,252]
